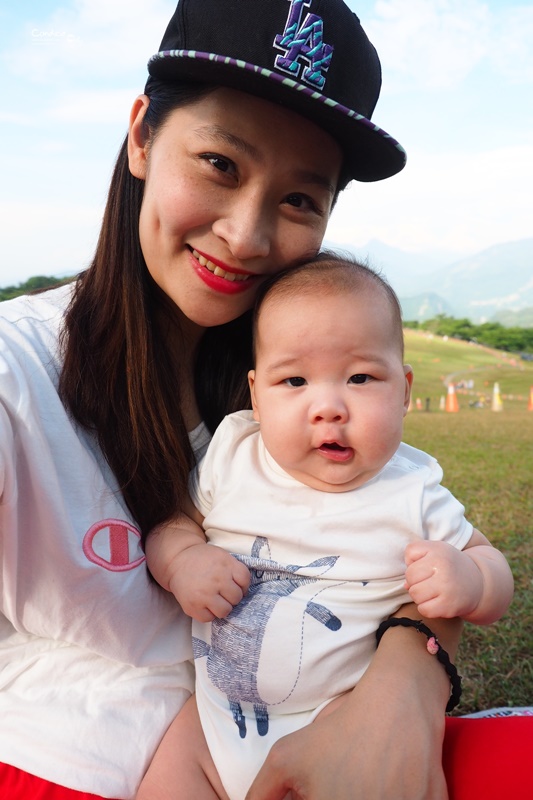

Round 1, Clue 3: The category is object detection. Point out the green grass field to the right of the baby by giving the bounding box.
[404,331,533,714]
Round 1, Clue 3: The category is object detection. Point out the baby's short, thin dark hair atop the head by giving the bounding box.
[253,250,404,360]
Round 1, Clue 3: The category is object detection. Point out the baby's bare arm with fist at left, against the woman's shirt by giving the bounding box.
[142,503,250,622]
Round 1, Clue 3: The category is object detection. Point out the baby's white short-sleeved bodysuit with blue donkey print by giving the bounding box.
[191,411,472,800]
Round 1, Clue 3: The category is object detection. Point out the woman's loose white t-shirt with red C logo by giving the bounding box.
[0,286,198,799]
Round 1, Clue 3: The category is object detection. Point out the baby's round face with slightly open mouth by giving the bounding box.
[249,286,412,492]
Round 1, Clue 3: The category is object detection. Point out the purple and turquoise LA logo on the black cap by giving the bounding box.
[274,0,333,90]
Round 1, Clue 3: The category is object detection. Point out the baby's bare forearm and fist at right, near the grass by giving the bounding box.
[405,529,514,625]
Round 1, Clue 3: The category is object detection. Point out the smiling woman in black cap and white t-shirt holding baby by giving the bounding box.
[0,0,520,800]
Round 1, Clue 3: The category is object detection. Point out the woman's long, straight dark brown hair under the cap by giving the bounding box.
[59,80,252,536]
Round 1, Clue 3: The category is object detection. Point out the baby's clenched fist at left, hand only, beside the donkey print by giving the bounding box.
[169,542,250,622]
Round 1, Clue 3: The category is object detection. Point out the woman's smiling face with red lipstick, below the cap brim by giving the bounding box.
[129,89,342,327]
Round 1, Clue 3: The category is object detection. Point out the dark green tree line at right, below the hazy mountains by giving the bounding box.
[403,314,533,360]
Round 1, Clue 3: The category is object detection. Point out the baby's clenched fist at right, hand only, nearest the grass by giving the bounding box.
[405,540,483,618]
